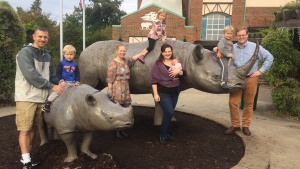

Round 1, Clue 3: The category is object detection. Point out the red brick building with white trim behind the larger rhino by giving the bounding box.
[112,0,291,46]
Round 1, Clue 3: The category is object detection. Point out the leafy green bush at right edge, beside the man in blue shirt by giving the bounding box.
[262,29,300,117]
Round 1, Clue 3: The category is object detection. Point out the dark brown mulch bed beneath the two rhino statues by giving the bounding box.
[0,107,245,169]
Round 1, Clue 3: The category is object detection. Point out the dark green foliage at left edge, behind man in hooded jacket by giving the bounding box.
[0,1,24,104]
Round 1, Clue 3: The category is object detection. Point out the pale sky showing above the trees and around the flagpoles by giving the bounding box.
[6,0,137,21]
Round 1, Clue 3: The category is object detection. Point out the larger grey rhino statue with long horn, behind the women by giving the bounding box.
[79,39,259,124]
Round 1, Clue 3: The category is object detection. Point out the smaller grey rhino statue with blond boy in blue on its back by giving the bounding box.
[41,84,133,162]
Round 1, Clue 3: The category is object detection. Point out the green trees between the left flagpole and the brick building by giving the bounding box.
[64,0,126,56]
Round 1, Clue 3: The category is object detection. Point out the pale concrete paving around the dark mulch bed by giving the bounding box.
[0,85,300,169]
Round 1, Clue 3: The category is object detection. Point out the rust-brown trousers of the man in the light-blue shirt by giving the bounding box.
[229,77,259,127]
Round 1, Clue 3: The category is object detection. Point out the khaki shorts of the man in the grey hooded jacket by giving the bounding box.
[16,102,44,131]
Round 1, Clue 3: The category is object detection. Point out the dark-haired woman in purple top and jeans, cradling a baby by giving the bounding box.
[150,44,183,144]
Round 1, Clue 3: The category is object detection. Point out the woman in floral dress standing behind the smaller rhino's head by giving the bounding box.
[106,45,141,138]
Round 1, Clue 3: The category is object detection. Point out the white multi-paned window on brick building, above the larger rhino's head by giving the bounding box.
[201,14,230,40]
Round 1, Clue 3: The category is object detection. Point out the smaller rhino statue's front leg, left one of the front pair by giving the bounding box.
[61,133,77,162]
